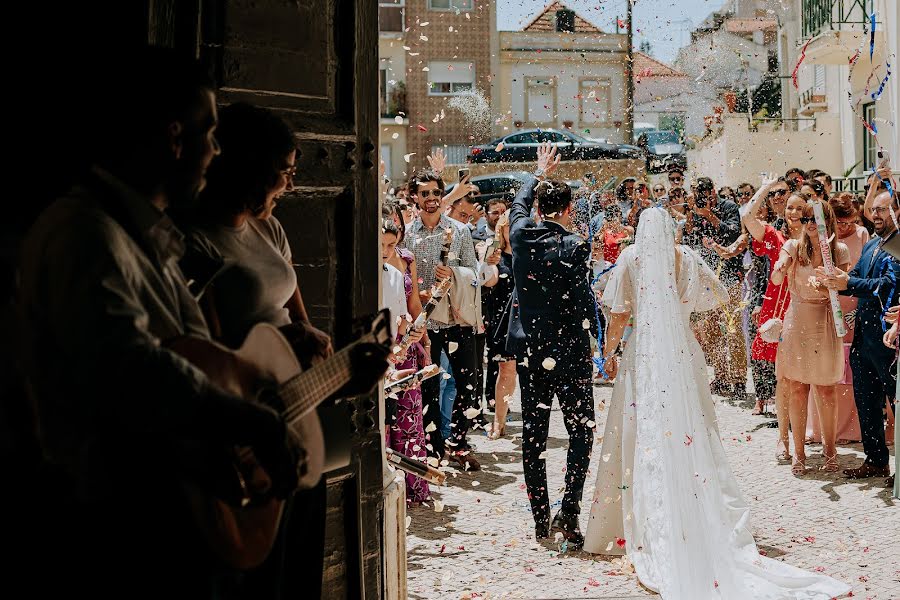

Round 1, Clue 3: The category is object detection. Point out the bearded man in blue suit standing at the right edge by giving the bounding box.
[818,190,900,479]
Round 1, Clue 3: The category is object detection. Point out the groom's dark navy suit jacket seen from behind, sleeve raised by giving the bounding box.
[506,173,597,360]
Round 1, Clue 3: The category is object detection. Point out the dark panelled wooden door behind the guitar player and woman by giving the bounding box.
[195,0,382,600]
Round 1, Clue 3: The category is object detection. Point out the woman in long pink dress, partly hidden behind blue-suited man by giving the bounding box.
[806,192,869,444]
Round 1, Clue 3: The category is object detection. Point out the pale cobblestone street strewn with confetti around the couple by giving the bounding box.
[407,386,900,600]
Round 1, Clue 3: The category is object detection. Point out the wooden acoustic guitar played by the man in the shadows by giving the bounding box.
[168,310,391,569]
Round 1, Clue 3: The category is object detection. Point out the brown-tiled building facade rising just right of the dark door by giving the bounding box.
[379,0,497,183]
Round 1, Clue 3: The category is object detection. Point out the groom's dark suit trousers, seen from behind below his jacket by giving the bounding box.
[517,356,594,523]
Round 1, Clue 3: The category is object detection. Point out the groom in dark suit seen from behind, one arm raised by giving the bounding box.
[507,144,597,549]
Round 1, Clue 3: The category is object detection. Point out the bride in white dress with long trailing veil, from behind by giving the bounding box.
[584,208,850,600]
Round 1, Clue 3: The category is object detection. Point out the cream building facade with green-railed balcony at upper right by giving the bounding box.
[778,0,900,188]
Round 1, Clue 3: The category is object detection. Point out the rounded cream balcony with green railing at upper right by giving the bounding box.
[800,0,884,65]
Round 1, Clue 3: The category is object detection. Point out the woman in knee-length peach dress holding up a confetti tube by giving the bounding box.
[772,202,850,475]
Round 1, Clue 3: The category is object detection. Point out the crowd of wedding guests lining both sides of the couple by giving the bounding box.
[383,159,900,510]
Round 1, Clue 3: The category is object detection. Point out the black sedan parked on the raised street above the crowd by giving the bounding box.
[466,129,644,163]
